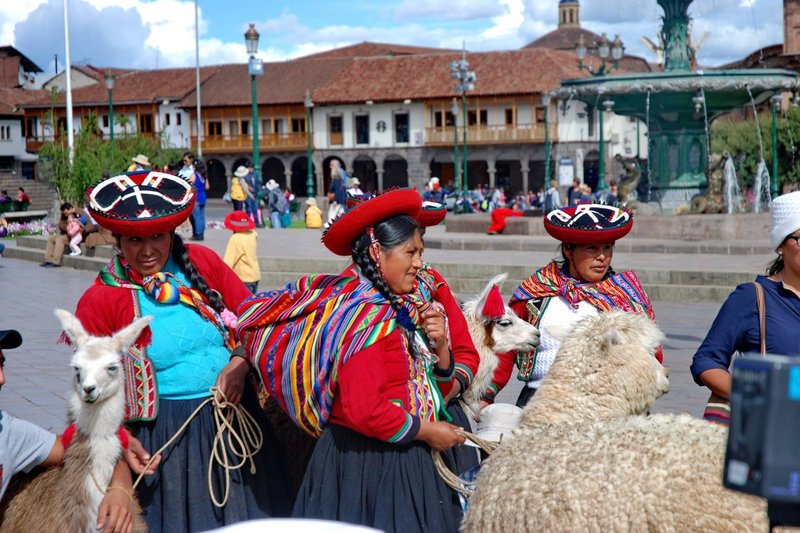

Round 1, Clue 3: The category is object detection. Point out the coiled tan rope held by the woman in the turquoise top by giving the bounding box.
[133,387,264,507]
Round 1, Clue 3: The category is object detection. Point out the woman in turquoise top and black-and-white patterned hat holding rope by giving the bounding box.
[70,171,291,531]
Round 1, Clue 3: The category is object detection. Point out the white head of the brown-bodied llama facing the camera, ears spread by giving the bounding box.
[55,309,153,403]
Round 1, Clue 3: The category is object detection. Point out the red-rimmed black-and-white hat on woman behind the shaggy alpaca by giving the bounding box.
[544,204,633,244]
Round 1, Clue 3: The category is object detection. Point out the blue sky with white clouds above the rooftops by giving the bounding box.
[0,0,783,76]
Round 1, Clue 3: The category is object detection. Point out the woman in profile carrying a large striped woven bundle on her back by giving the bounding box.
[238,189,464,532]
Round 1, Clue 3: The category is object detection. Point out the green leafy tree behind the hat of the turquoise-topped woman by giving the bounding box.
[39,114,183,205]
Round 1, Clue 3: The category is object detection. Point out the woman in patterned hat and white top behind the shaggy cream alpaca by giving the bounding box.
[484,204,662,407]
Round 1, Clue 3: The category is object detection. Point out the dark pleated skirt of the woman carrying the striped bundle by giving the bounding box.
[294,424,462,533]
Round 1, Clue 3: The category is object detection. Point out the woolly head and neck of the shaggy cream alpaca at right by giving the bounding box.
[532,311,669,420]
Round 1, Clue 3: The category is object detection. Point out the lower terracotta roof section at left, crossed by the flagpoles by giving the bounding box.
[25,66,221,107]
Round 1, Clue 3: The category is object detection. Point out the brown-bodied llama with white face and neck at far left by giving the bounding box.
[0,309,153,532]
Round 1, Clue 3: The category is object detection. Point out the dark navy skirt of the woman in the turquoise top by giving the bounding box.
[130,387,294,533]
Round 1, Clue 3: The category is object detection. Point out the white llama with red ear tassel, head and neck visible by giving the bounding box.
[461,273,539,419]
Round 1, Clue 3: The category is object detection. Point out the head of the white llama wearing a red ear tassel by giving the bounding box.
[463,272,539,353]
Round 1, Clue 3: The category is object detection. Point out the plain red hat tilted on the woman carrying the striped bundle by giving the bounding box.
[322,189,422,255]
